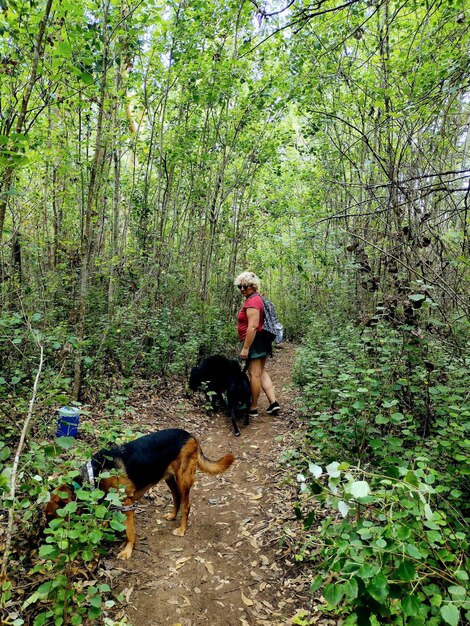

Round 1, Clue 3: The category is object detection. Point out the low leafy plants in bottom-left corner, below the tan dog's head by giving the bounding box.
[0,423,132,626]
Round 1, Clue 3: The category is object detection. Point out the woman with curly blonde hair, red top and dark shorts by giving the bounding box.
[235,272,281,417]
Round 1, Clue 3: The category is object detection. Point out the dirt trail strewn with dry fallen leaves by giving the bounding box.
[105,344,306,626]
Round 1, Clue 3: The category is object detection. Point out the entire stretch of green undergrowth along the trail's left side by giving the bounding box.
[0,299,250,626]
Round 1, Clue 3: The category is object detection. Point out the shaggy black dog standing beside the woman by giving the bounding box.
[189,354,251,437]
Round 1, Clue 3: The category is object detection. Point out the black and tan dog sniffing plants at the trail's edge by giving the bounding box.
[45,428,235,559]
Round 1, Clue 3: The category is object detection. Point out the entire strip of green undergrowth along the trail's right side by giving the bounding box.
[290,318,470,626]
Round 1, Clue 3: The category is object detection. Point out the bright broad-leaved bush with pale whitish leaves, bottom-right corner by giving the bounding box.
[296,462,470,626]
